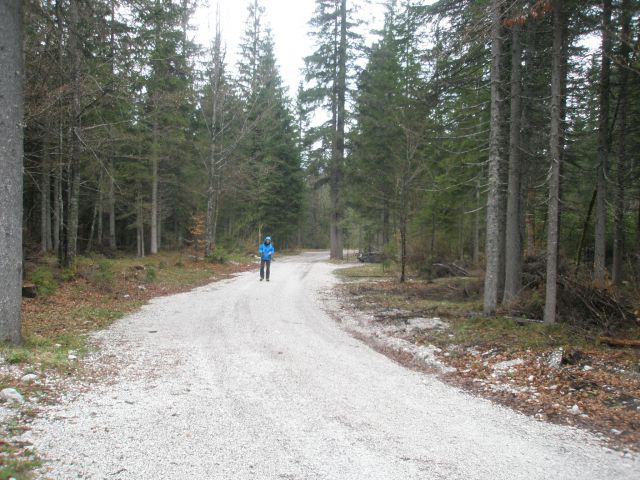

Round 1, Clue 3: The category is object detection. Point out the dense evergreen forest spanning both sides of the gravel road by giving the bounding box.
[0,0,640,338]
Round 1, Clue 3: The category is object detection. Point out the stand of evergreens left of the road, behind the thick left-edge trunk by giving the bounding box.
[24,0,304,266]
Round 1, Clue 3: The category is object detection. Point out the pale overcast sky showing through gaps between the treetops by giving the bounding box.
[194,0,383,95]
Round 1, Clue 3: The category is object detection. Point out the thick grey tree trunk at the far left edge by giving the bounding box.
[0,0,24,343]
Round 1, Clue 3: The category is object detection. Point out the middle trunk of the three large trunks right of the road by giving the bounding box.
[503,24,522,303]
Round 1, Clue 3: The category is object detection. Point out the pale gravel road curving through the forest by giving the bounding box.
[26,253,640,480]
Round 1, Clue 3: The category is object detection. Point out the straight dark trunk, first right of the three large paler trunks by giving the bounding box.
[593,0,611,288]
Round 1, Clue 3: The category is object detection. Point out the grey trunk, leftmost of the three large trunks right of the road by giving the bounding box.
[484,0,504,315]
